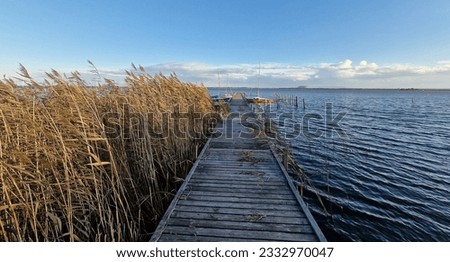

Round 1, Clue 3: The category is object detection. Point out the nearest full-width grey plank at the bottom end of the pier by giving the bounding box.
[166,225,317,242]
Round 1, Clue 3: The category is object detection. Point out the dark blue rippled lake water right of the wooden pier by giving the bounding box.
[211,89,450,241]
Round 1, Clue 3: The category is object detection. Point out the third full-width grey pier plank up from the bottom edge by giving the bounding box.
[171,210,309,225]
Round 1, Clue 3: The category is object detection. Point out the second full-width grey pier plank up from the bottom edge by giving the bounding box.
[163,218,314,234]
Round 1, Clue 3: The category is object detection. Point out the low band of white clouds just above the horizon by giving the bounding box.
[8,59,450,88]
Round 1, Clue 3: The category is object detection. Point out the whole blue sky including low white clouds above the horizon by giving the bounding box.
[0,0,450,88]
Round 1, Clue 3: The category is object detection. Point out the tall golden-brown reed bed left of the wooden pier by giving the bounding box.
[0,68,214,241]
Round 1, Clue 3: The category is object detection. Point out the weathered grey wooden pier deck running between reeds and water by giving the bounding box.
[150,94,326,241]
